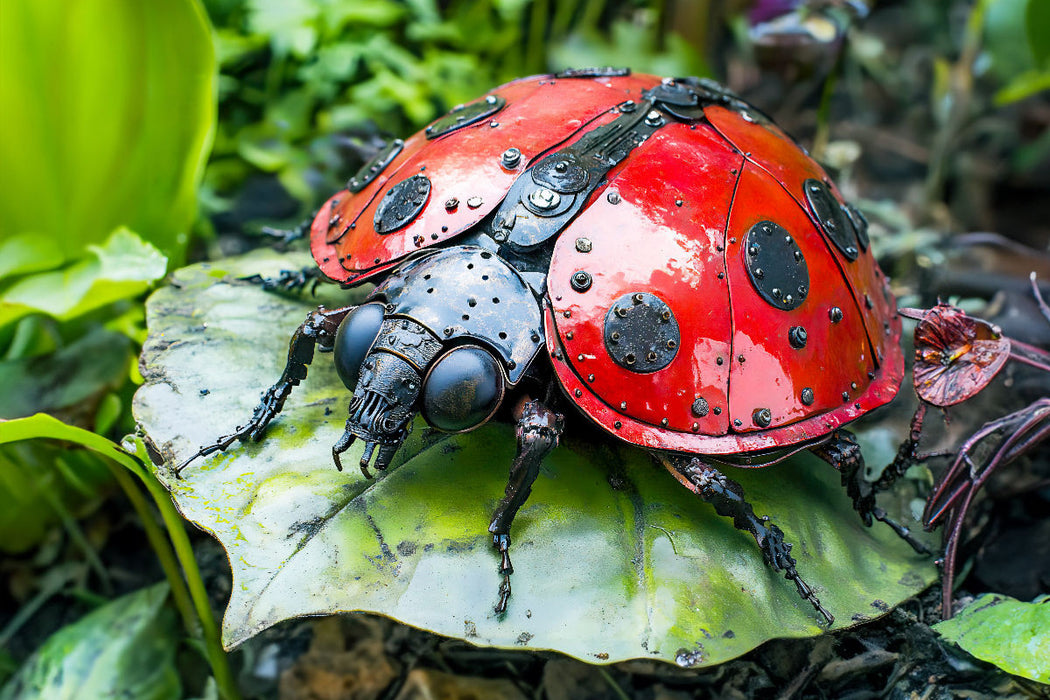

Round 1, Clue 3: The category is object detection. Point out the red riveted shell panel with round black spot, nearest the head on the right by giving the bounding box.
[547,123,742,440]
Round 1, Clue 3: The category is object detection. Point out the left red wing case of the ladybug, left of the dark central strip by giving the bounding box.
[311,76,659,283]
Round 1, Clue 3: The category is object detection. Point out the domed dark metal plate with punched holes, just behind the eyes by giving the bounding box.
[372,246,543,384]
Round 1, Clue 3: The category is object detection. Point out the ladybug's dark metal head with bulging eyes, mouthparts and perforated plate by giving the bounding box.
[334,249,541,469]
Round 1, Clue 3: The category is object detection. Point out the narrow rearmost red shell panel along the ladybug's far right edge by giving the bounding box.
[705,106,903,367]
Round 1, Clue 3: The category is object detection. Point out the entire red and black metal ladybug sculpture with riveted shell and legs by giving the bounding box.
[179,68,924,623]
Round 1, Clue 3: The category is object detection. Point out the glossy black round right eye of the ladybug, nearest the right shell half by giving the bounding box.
[423,345,504,432]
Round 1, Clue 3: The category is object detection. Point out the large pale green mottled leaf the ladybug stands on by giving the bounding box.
[135,253,936,664]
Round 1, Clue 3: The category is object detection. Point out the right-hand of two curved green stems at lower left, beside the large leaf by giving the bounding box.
[137,472,240,700]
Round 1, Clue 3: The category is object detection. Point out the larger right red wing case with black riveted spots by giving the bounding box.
[546,89,903,454]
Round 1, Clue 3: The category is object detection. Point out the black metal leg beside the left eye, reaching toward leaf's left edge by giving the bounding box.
[175,306,356,476]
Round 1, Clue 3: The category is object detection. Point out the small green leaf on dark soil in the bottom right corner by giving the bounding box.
[933,593,1050,683]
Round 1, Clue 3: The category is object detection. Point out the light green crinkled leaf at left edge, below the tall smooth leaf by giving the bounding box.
[0,228,167,325]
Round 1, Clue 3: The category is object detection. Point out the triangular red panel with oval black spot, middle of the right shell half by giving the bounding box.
[726,163,899,434]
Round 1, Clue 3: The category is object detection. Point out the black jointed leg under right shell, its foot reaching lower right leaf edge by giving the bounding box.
[657,453,835,624]
